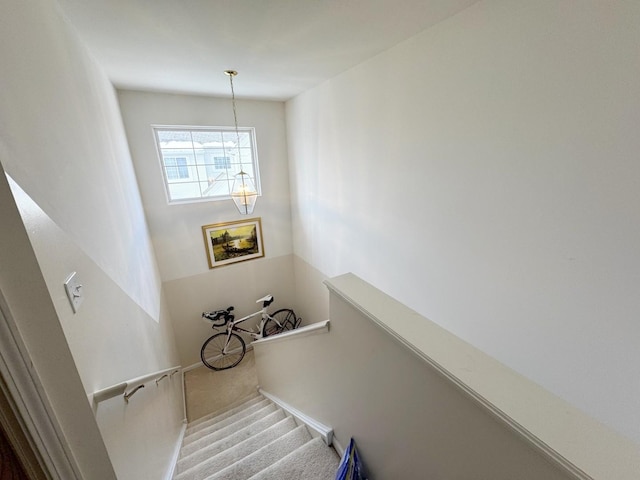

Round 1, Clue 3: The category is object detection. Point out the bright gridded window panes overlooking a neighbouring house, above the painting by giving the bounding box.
[154,127,260,203]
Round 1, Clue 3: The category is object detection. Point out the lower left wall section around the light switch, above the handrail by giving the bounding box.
[10,178,181,392]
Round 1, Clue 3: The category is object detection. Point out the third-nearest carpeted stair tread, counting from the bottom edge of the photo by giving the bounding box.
[175,416,297,480]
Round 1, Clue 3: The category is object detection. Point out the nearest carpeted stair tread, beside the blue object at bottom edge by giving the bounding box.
[250,438,340,480]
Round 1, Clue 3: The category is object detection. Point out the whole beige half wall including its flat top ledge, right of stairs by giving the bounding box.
[254,274,640,480]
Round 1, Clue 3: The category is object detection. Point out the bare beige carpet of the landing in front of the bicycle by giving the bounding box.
[184,350,258,422]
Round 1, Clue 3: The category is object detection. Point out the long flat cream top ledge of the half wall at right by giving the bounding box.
[324,274,640,480]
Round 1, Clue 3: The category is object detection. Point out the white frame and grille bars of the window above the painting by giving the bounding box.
[151,125,262,205]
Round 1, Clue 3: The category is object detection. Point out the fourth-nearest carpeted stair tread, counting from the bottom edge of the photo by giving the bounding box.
[175,409,288,475]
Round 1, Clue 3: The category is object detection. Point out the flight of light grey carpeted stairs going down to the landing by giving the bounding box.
[173,393,340,480]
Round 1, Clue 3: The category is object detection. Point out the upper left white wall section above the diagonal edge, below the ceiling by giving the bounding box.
[0,0,160,319]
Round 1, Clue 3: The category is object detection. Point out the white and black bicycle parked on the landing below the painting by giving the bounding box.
[200,295,302,370]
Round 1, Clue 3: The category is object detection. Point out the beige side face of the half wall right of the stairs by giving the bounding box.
[254,276,573,480]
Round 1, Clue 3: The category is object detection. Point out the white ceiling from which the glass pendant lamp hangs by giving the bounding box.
[57,0,478,100]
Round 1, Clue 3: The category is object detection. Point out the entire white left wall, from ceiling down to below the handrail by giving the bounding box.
[0,0,183,479]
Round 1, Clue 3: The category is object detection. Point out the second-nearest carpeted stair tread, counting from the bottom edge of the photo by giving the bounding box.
[200,425,311,480]
